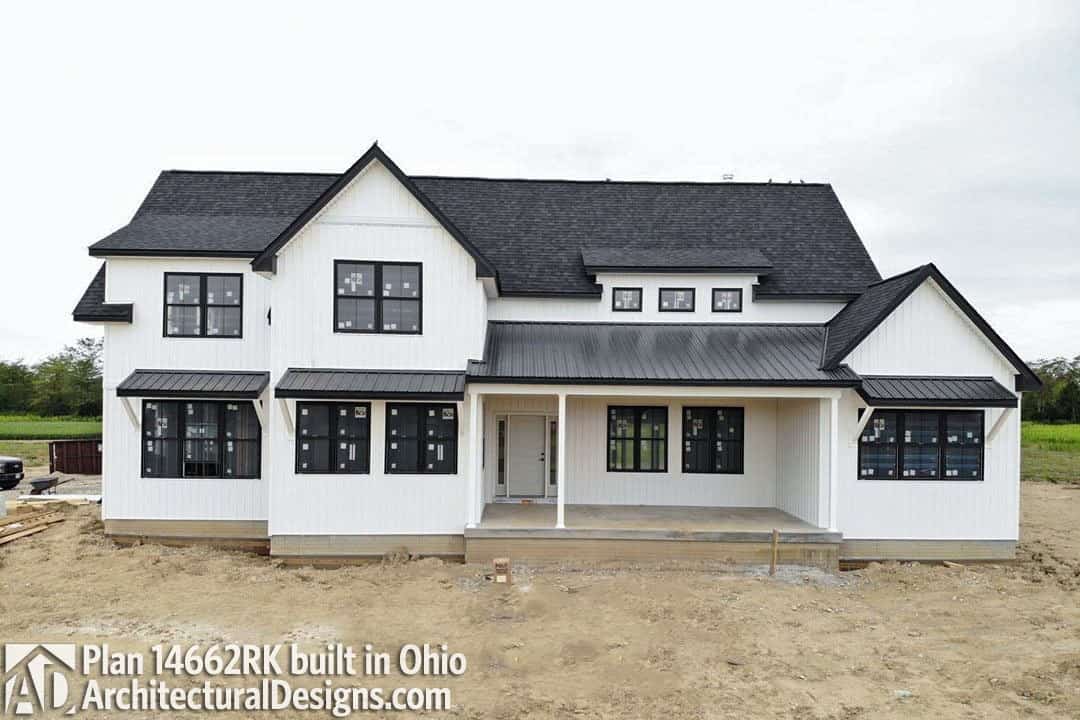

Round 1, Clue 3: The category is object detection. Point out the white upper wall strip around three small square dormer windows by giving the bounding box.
[488,273,845,323]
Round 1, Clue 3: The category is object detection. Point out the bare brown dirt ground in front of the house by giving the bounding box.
[0,483,1080,720]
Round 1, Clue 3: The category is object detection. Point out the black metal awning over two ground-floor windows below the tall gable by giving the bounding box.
[274,368,465,400]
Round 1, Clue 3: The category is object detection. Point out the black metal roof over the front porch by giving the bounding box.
[469,322,859,386]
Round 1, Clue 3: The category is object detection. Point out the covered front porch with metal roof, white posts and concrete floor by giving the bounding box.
[455,323,858,566]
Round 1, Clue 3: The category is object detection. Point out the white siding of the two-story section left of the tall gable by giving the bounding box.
[102,257,270,520]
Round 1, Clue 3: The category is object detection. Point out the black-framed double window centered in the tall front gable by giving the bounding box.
[334,260,423,335]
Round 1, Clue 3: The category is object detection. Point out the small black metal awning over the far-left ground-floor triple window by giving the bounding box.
[117,370,270,399]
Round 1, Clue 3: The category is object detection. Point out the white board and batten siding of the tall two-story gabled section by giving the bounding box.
[270,162,487,535]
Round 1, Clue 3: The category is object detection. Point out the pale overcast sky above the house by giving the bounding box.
[0,0,1080,361]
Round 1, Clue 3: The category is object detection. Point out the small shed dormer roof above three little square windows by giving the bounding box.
[581,247,772,275]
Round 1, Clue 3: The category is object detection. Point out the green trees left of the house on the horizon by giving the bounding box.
[0,338,104,418]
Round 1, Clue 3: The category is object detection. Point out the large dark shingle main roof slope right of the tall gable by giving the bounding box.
[414,177,880,297]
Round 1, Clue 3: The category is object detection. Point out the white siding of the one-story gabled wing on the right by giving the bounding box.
[838,280,1021,540]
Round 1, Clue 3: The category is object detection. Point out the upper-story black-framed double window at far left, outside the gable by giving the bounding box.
[162,272,244,338]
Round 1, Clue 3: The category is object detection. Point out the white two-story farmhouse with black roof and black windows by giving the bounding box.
[75,142,1039,567]
